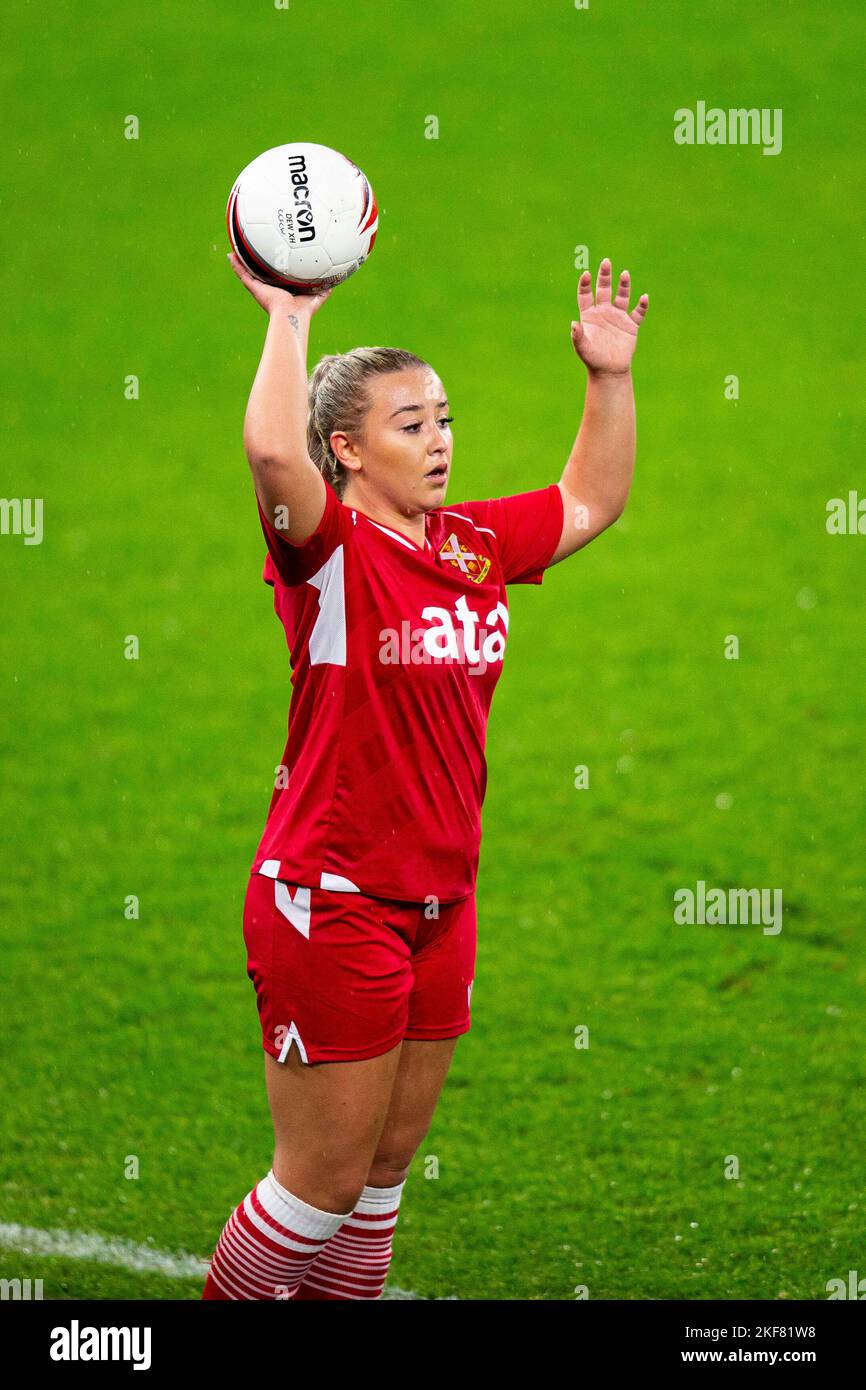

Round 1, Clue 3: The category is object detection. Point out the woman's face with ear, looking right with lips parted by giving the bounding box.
[331,367,453,516]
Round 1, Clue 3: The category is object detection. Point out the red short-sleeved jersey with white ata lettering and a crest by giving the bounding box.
[252,482,563,902]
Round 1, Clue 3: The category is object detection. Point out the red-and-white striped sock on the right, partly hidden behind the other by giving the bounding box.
[292,1180,405,1301]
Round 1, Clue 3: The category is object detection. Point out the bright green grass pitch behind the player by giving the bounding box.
[0,0,866,1300]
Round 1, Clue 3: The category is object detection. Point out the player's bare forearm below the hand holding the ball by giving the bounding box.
[243,304,310,464]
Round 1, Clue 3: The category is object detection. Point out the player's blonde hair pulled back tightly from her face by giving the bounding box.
[307,348,430,498]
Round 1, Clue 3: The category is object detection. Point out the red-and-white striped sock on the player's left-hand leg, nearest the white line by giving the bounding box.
[202,1169,352,1300]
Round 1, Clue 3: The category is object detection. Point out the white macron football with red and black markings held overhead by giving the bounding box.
[225,142,378,293]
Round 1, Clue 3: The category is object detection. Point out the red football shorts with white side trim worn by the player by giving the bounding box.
[243,873,475,1062]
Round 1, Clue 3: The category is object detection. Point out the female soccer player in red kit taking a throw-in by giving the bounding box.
[203,256,648,1300]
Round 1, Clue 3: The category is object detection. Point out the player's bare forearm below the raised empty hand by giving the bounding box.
[562,371,635,524]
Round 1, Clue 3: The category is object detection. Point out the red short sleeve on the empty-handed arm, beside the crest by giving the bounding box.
[453,482,564,584]
